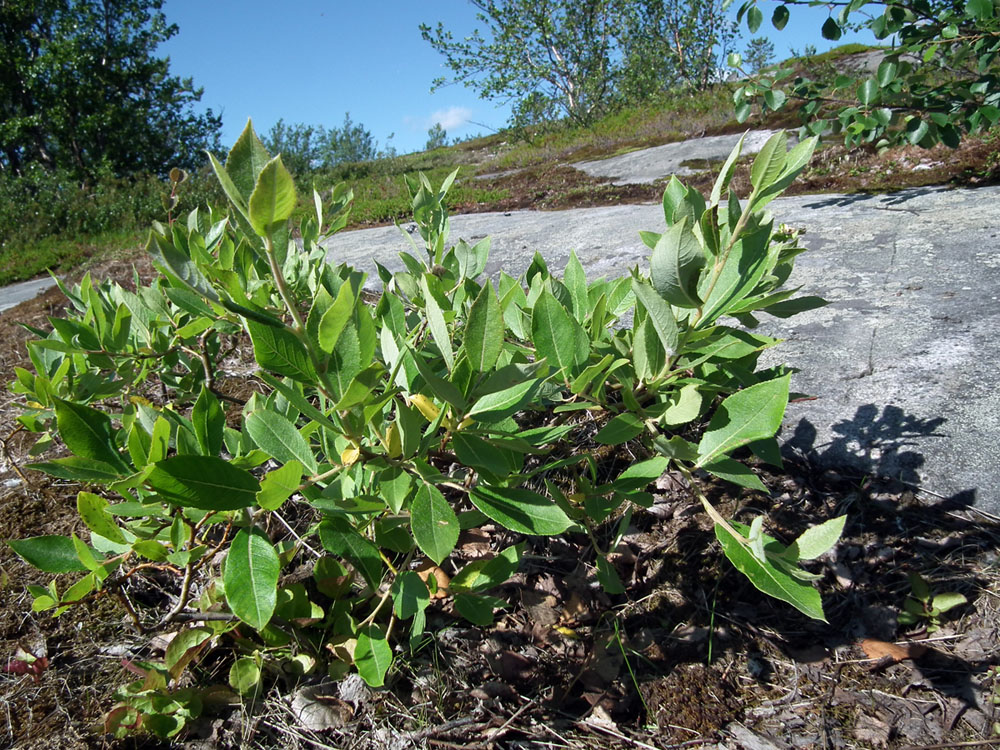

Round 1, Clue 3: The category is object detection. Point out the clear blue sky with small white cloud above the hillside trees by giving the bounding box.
[158,0,870,153]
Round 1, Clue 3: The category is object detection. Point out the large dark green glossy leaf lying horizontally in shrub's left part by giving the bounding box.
[147,456,260,511]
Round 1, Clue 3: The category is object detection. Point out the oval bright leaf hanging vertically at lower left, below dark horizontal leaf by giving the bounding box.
[222,529,281,630]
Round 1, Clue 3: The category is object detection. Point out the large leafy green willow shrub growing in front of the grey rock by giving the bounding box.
[10,126,844,736]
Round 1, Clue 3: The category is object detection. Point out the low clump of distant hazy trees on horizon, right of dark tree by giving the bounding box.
[263,112,378,174]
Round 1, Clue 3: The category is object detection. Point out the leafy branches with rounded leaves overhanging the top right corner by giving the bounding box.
[735,0,1000,148]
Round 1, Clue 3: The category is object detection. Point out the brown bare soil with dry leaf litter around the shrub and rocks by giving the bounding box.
[0,140,1000,750]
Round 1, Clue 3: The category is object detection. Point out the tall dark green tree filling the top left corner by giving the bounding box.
[0,0,222,176]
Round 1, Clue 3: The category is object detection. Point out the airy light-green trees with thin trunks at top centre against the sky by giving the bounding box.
[420,0,732,124]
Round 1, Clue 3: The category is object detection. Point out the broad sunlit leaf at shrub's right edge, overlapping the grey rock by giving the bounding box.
[696,374,792,468]
